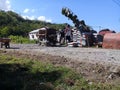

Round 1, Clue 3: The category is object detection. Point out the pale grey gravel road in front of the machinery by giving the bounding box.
[8,44,120,65]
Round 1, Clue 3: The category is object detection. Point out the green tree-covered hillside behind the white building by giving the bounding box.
[0,11,64,37]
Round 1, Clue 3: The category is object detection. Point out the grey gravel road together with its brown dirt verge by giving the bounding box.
[1,44,120,84]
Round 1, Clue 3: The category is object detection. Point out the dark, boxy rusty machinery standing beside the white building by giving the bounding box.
[37,27,57,46]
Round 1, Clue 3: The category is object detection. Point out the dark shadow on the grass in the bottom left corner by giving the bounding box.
[0,64,61,90]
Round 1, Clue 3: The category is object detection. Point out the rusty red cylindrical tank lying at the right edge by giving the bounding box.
[102,33,120,49]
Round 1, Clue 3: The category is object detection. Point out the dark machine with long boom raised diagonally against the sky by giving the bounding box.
[62,7,97,46]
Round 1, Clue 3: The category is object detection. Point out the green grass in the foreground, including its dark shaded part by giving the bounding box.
[0,54,120,90]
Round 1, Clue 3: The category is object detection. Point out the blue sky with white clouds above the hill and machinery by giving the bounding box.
[0,0,120,32]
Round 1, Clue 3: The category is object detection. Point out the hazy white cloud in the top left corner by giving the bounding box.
[0,0,11,11]
